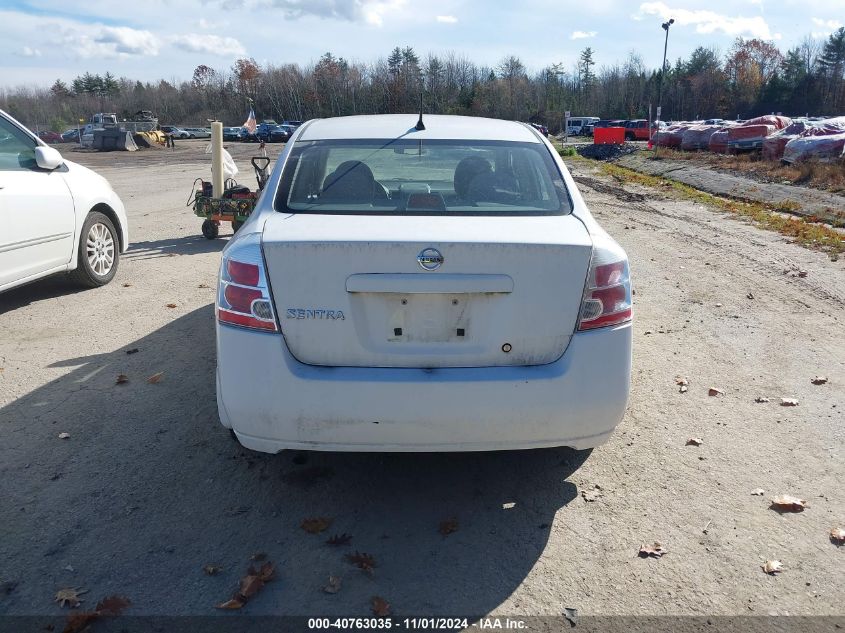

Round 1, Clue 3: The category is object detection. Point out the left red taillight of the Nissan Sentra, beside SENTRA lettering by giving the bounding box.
[217,233,279,332]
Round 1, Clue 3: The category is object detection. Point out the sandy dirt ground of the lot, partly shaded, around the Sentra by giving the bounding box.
[0,141,845,616]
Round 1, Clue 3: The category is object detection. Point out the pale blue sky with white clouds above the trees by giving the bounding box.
[0,0,845,88]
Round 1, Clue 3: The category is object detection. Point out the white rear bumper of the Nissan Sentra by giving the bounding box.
[217,323,631,453]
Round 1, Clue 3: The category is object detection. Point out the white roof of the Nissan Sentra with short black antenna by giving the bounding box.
[299,114,541,143]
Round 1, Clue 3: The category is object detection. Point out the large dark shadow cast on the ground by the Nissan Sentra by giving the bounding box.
[0,305,587,615]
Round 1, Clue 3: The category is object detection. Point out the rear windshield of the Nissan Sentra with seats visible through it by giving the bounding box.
[275,139,571,215]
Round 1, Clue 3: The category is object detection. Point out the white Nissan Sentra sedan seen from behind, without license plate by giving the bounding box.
[216,115,631,453]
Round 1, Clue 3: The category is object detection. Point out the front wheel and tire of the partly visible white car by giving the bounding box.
[71,211,120,288]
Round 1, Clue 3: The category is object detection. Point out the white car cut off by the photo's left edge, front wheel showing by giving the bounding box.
[0,110,129,292]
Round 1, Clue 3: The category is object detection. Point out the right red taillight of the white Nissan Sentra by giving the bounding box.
[578,238,631,330]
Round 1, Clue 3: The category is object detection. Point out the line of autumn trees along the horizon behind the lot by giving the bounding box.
[0,28,845,132]
